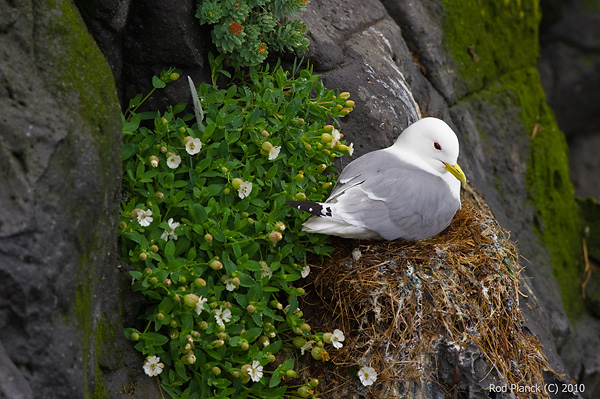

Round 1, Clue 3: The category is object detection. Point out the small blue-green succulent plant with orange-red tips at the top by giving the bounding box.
[196,0,309,66]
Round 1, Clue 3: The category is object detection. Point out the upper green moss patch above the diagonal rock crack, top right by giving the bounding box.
[441,0,541,93]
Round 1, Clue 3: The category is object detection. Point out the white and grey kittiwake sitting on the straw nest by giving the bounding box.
[288,118,466,240]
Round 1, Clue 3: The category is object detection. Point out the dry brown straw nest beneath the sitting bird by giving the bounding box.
[303,189,550,398]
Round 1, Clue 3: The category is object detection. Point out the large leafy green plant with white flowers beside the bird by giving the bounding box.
[119,56,354,398]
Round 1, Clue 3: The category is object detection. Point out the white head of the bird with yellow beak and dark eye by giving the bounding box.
[394,118,466,184]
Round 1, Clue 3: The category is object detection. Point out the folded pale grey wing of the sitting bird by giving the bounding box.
[328,151,460,240]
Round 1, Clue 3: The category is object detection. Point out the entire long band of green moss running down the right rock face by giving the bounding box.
[442,0,584,317]
